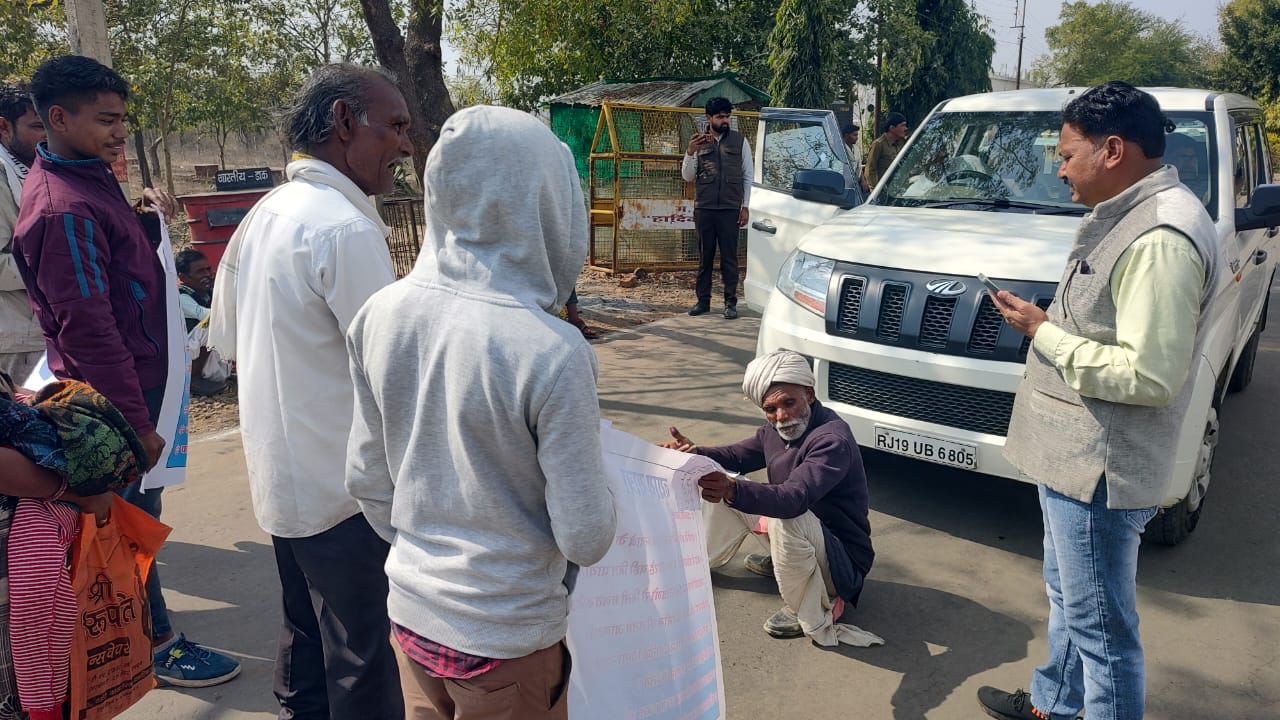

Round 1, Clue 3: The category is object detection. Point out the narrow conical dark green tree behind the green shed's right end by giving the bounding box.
[769,0,837,108]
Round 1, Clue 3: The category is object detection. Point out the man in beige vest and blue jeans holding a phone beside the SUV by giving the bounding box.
[978,82,1221,720]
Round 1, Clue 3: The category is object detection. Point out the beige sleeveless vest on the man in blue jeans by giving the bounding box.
[1005,167,1224,510]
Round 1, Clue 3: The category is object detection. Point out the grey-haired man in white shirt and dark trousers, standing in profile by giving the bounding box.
[210,64,413,720]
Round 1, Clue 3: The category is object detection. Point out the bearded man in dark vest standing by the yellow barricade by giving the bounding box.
[680,97,754,320]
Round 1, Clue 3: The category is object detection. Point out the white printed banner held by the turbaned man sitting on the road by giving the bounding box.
[566,428,724,720]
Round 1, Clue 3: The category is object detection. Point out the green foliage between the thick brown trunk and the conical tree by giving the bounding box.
[448,0,774,109]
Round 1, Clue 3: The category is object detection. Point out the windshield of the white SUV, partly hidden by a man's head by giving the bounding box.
[873,111,1216,217]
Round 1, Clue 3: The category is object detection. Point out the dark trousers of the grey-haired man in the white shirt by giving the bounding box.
[271,515,404,720]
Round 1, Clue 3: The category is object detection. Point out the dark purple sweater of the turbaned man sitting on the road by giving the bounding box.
[698,402,876,602]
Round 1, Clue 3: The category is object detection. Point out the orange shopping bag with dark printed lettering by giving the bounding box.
[70,498,170,720]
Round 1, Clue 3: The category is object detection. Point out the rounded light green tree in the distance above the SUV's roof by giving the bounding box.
[1032,0,1215,87]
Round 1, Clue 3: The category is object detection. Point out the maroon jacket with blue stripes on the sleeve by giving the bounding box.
[13,143,168,427]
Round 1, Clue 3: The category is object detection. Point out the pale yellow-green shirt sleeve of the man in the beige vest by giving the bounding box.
[1033,228,1204,407]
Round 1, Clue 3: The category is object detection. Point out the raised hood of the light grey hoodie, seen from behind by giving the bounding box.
[412,105,588,313]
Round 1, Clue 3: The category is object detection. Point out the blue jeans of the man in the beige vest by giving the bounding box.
[1032,478,1156,720]
